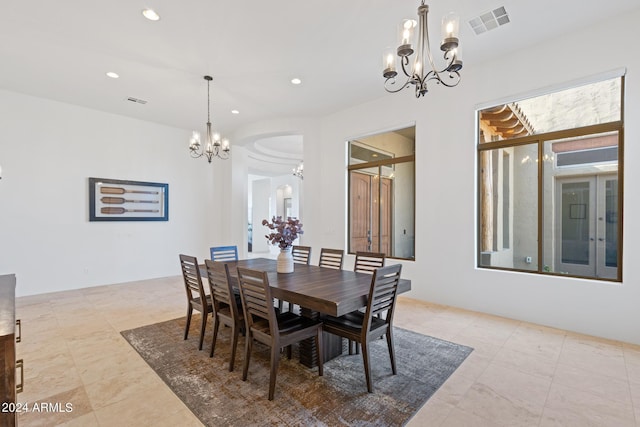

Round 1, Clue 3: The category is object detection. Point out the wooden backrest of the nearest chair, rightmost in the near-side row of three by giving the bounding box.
[238,267,278,337]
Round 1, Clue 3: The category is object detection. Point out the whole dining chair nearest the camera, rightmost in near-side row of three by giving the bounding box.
[238,267,322,400]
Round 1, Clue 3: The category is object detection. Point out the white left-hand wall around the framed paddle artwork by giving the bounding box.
[0,91,219,296]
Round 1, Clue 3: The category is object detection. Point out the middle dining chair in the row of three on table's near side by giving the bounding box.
[204,259,244,372]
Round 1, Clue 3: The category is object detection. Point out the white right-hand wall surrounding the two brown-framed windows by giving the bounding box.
[232,10,640,344]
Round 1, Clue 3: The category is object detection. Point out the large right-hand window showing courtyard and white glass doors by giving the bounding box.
[478,77,624,281]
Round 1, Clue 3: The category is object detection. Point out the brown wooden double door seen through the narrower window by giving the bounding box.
[349,171,393,256]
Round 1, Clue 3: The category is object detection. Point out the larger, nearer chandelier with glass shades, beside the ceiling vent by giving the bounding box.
[382,0,462,98]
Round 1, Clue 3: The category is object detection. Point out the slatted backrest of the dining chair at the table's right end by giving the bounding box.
[363,264,402,332]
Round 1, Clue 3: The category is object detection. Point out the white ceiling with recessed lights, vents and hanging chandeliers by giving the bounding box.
[0,0,639,174]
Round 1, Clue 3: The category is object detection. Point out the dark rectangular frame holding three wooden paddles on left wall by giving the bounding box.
[89,178,169,222]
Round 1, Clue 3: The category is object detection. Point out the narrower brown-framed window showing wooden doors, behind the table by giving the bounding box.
[348,127,415,259]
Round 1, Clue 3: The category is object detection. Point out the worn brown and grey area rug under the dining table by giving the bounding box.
[122,315,473,427]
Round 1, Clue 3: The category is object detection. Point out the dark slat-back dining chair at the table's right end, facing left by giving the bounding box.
[323,264,402,393]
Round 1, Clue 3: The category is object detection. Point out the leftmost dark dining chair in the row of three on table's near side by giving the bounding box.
[180,255,213,350]
